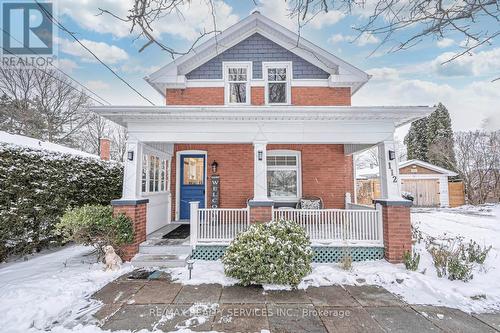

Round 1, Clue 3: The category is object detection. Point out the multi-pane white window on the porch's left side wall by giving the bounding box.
[141,154,169,193]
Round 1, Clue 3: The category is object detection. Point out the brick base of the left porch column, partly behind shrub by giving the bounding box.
[111,199,149,261]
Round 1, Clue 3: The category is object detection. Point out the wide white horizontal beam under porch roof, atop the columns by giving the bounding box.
[127,119,394,144]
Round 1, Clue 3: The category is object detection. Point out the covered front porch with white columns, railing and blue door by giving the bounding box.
[99,106,429,262]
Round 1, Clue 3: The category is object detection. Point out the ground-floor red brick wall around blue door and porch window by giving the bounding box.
[171,144,354,219]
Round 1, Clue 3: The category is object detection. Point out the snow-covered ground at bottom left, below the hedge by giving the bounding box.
[0,246,132,332]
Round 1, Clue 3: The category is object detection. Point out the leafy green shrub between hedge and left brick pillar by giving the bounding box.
[55,205,134,260]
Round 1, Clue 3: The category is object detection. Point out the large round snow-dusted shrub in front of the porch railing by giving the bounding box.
[222,221,313,286]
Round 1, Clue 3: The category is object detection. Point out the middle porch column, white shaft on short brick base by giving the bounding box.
[248,141,273,223]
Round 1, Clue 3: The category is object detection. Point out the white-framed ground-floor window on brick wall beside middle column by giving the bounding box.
[267,151,301,201]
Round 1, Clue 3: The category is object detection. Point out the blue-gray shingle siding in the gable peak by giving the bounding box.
[186,33,330,80]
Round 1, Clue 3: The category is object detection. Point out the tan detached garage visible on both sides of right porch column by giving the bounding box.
[356,160,465,207]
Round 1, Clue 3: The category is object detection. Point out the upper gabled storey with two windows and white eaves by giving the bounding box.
[145,12,370,106]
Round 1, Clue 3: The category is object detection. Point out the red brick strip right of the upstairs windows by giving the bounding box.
[292,87,351,105]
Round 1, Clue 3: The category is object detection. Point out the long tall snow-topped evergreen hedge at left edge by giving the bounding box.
[0,143,123,261]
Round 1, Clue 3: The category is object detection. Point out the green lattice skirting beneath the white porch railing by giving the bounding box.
[192,245,384,263]
